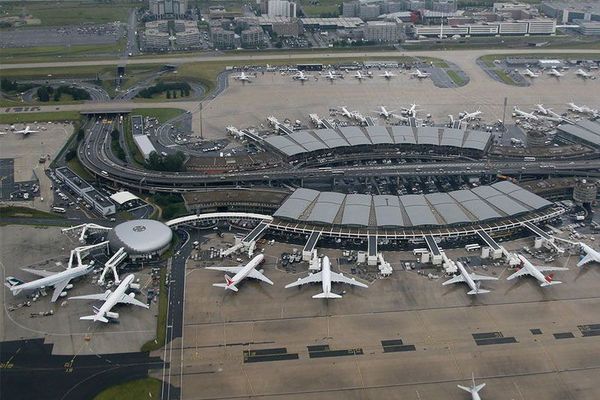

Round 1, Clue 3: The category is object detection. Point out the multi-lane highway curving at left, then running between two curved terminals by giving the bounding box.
[78,118,600,192]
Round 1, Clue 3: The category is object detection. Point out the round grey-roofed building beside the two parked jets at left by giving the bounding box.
[108,219,173,260]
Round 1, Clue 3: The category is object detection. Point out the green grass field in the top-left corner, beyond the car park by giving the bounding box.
[2,1,134,26]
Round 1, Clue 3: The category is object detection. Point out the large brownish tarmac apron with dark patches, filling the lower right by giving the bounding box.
[170,235,600,400]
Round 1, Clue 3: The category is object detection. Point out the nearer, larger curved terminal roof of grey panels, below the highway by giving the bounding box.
[273,181,552,228]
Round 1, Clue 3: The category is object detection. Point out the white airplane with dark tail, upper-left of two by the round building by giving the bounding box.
[4,264,94,302]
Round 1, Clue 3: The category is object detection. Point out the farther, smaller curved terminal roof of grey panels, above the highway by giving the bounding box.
[264,125,492,157]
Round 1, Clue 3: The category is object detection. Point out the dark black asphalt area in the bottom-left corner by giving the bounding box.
[0,339,163,400]
